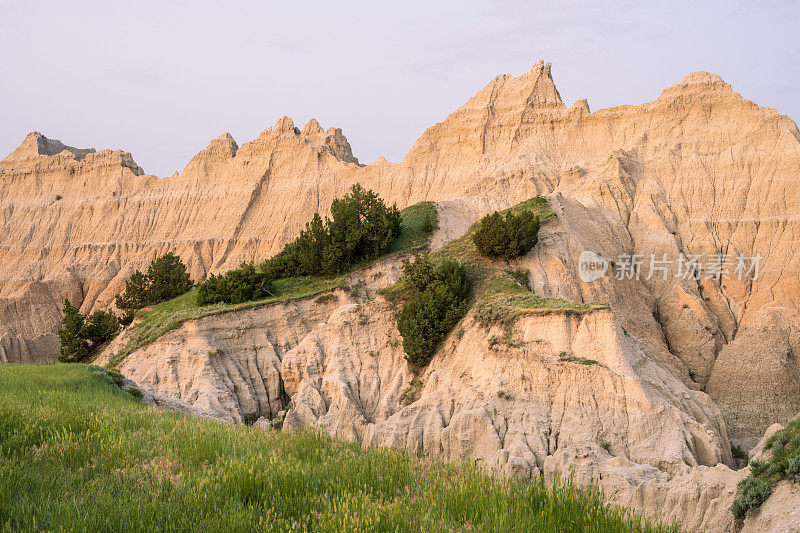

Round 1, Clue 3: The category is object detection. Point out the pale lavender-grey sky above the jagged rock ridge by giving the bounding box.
[0,0,800,176]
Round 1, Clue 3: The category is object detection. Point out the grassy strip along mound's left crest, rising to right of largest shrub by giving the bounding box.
[108,202,436,368]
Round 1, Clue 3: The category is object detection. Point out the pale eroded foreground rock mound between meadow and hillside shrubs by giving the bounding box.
[99,210,800,531]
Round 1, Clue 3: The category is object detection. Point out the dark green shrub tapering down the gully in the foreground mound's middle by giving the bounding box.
[397,255,470,366]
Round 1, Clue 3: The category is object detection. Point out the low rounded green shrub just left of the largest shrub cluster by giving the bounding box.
[197,263,273,305]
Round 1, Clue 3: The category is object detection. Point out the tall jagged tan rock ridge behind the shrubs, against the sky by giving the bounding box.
[0,62,800,444]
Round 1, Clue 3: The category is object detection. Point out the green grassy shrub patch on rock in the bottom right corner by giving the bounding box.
[731,417,800,520]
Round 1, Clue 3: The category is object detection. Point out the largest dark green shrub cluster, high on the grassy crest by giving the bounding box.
[261,183,402,279]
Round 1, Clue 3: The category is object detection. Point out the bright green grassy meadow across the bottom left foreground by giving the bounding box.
[0,364,677,532]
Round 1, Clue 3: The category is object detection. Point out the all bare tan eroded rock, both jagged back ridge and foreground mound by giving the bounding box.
[0,61,800,531]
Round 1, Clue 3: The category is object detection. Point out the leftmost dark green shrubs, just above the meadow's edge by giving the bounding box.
[58,300,119,363]
